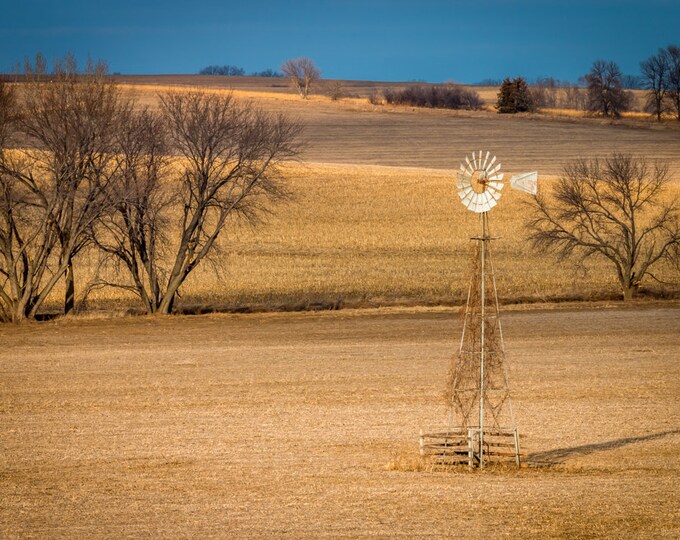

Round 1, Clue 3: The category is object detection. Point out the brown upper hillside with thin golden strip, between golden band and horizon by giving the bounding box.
[119,76,680,175]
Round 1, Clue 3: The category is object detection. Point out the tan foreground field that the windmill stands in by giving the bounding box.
[0,303,680,538]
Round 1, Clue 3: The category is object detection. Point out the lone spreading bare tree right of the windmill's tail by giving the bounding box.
[528,154,680,300]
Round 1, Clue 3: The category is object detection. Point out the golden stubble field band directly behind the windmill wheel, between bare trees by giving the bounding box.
[65,164,680,309]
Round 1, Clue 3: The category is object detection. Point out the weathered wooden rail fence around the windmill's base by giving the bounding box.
[420,426,521,467]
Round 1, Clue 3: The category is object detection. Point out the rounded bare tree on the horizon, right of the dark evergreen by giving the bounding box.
[584,60,632,118]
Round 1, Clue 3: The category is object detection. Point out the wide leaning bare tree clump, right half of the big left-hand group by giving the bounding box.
[99,92,300,313]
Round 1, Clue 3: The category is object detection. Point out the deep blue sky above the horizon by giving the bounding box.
[0,0,680,83]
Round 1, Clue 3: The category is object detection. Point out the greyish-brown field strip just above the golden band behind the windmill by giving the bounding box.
[300,104,680,174]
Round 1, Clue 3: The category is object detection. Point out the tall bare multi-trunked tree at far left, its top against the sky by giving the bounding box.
[4,56,127,317]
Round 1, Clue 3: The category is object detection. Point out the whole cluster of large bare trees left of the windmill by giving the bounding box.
[0,58,301,321]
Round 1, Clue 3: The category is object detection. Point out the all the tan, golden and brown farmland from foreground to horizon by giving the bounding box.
[0,76,680,539]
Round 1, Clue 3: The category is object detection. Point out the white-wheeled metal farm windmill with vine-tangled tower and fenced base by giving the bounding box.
[420,151,538,468]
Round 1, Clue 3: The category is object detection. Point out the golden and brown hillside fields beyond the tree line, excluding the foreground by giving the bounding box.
[14,77,680,311]
